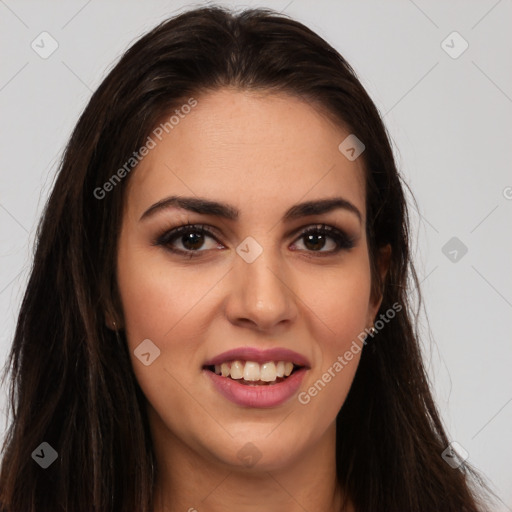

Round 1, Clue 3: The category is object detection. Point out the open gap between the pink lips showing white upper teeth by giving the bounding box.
[203,359,304,386]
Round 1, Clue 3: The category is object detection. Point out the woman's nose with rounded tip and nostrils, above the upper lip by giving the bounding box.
[226,245,297,334]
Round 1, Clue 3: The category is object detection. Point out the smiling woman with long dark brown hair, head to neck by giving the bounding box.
[0,7,492,512]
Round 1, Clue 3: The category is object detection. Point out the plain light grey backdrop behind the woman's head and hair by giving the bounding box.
[0,0,512,511]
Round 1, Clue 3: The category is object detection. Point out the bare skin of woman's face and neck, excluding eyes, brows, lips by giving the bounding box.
[113,88,389,512]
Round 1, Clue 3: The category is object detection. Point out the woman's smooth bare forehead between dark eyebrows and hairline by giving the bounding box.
[127,89,365,222]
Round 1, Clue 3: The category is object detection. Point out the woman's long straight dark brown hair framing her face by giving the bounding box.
[0,7,492,512]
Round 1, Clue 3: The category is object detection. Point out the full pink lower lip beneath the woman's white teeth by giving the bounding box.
[203,368,307,408]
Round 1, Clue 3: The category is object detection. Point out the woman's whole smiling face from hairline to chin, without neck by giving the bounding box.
[117,89,379,469]
